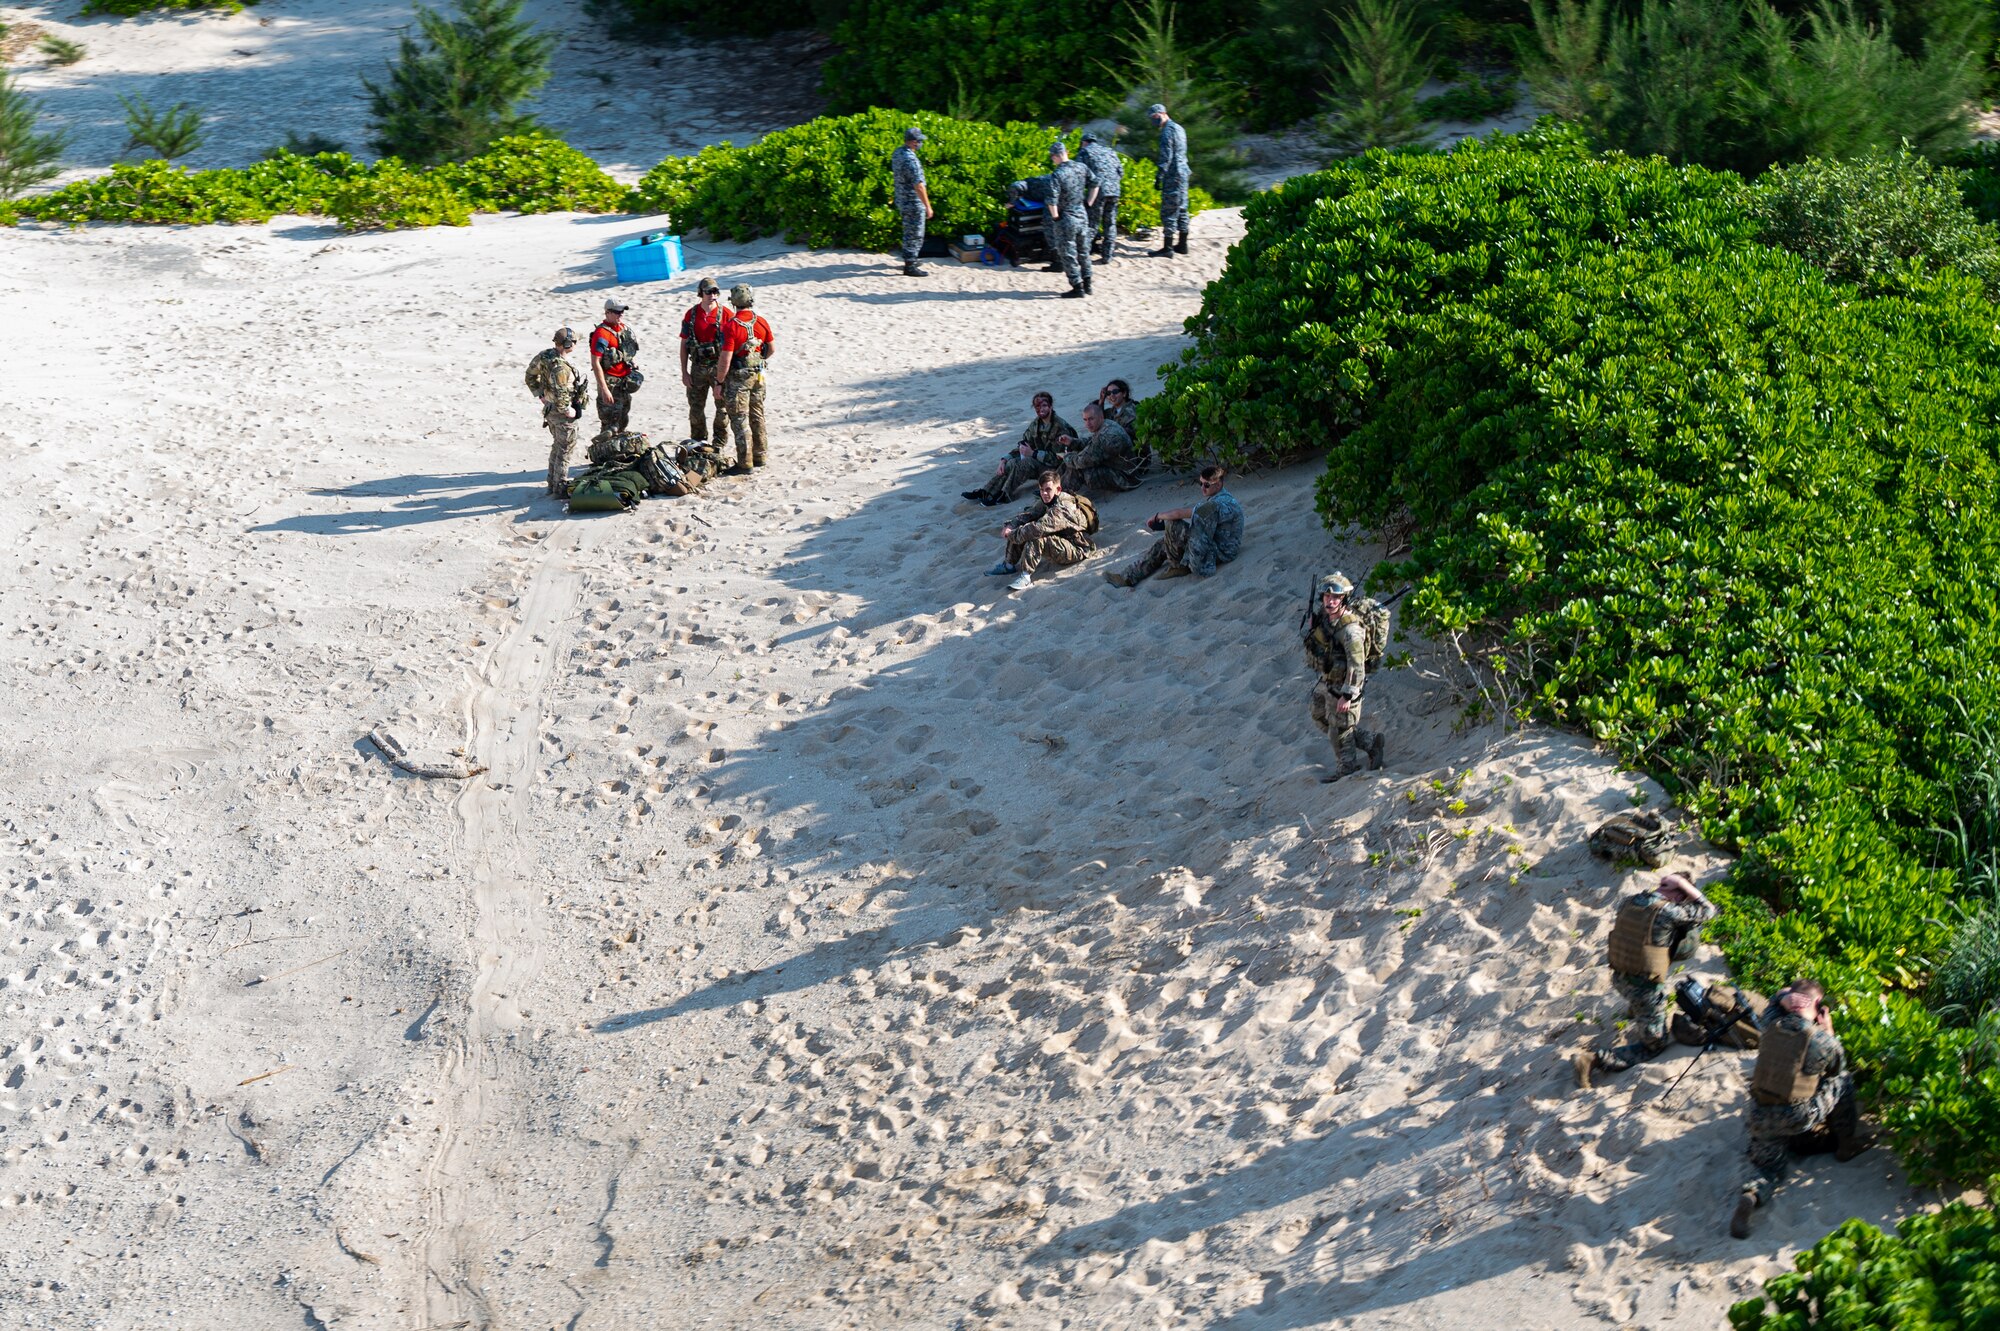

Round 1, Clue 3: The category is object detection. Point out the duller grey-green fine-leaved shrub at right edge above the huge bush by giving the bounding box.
[1752,148,2000,298]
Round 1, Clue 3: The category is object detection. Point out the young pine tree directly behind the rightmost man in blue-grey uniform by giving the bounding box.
[1112,0,1250,202]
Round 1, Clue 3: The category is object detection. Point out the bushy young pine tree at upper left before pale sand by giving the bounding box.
[362,0,556,166]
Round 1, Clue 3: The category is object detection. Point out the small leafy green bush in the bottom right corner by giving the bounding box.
[1730,1201,2000,1331]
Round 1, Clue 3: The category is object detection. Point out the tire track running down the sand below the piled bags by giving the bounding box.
[412,524,584,1327]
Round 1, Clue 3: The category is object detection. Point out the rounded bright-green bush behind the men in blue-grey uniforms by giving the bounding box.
[632,110,1212,250]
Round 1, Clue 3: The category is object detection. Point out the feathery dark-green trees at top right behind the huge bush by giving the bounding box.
[1526,0,1980,174]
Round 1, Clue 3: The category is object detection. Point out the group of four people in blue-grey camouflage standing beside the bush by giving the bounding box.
[890,102,1190,298]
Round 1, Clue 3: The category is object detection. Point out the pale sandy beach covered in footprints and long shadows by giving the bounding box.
[0,4,1934,1331]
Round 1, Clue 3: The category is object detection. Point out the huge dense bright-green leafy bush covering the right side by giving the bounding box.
[1142,136,2000,1177]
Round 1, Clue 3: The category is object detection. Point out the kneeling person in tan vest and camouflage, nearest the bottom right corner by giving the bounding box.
[1730,979,1874,1239]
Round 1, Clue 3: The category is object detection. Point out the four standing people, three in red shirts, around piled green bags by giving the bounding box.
[526,278,776,498]
